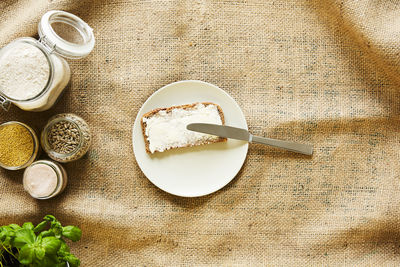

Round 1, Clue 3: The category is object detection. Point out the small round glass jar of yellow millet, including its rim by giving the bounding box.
[0,121,39,170]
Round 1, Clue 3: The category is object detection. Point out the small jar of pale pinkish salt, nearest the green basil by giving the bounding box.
[23,160,68,199]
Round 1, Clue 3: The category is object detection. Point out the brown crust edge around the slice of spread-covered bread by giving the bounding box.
[140,102,227,154]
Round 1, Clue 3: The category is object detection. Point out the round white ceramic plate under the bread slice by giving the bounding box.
[132,81,248,197]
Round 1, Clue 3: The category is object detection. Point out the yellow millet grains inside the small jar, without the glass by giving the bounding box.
[0,124,33,167]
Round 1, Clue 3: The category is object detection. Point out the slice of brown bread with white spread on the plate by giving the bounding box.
[141,102,227,154]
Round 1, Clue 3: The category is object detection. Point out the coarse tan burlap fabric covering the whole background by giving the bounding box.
[0,0,400,266]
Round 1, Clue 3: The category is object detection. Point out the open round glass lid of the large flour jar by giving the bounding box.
[39,10,95,58]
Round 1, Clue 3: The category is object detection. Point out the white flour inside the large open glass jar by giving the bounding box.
[0,43,50,100]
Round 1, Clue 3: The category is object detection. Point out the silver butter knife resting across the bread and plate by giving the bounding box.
[186,123,313,155]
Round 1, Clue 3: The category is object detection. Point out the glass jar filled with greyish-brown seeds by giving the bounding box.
[41,113,91,162]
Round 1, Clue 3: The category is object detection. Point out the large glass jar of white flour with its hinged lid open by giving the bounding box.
[0,10,95,111]
